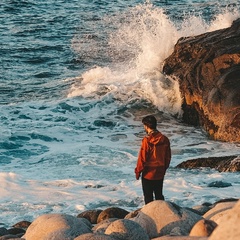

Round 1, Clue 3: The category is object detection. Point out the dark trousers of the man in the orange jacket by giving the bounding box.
[142,177,164,204]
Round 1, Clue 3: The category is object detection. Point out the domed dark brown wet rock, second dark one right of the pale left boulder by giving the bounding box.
[97,207,129,223]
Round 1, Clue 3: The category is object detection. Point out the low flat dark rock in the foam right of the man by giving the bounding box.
[176,156,240,172]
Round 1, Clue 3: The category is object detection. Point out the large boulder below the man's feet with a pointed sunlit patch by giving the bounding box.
[132,200,202,239]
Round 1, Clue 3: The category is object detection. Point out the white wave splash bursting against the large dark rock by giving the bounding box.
[68,2,239,115]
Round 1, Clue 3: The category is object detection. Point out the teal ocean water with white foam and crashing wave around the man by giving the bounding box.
[0,0,240,226]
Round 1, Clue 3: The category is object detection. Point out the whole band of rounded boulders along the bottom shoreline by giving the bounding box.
[0,199,240,240]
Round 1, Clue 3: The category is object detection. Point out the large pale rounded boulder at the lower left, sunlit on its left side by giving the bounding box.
[23,214,92,240]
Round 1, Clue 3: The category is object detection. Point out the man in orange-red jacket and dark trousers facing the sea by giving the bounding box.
[135,115,171,204]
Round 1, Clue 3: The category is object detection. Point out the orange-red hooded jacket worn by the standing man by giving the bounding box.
[135,130,171,180]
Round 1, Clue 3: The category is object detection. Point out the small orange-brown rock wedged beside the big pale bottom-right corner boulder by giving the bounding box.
[189,219,217,237]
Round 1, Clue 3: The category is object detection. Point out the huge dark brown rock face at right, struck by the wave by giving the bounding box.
[163,19,240,142]
